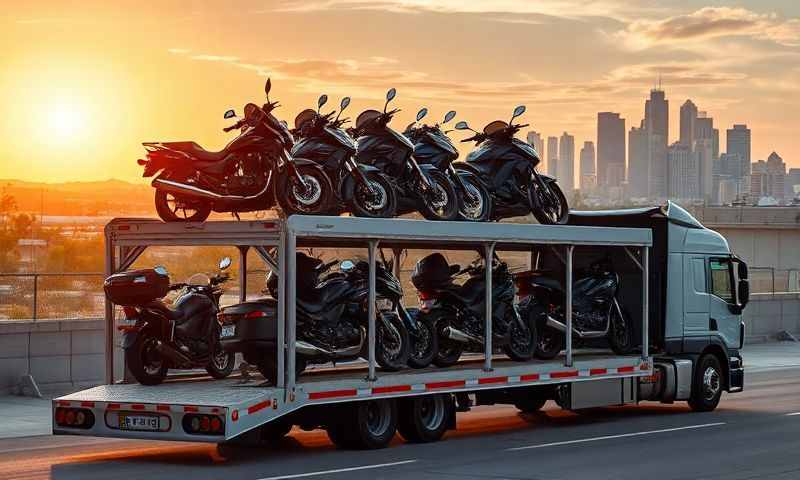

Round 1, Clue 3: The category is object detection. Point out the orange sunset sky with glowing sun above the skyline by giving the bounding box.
[0,0,800,182]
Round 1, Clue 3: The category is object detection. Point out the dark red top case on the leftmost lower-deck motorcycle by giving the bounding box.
[103,268,169,306]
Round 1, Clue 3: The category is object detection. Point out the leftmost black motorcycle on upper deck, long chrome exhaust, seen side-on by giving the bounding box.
[138,79,333,222]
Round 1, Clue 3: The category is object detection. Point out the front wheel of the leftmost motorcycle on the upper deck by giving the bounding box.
[276,165,333,216]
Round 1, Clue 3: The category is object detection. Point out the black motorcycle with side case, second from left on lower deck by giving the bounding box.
[220,253,409,382]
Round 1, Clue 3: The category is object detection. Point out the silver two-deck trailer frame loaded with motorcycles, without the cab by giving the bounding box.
[53,203,741,447]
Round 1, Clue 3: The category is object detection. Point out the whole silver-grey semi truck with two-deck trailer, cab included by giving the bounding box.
[52,203,749,448]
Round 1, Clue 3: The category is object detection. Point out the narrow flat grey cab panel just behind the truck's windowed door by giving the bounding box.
[683,255,709,337]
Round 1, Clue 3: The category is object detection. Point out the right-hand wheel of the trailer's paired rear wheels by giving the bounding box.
[397,394,453,443]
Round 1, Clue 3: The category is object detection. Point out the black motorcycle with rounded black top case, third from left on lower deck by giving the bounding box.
[411,253,536,367]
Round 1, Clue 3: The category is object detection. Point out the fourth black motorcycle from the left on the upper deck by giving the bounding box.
[403,108,492,222]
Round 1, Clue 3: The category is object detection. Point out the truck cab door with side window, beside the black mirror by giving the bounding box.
[708,257,740,348]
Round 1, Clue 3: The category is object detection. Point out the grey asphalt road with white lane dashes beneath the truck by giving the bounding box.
[0,368,800,480]
